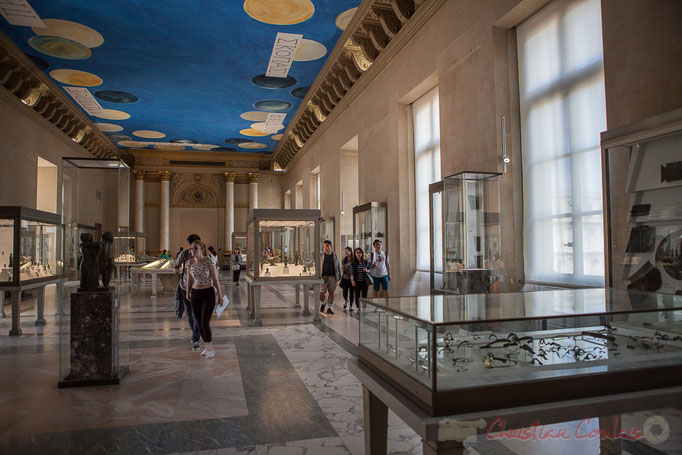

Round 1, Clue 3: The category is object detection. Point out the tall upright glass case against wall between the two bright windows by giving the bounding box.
[429,172,505,294]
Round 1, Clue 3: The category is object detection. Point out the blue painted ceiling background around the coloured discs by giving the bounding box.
[0,0,360,152]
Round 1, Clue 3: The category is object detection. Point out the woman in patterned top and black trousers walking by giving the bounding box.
[186,240,223,359]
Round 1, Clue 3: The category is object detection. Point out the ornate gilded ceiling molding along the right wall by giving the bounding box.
[273,0,446,169]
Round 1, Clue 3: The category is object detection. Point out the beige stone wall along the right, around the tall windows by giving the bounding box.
[282,0,682,295]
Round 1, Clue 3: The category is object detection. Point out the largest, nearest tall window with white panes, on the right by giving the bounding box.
[517,0,606,286]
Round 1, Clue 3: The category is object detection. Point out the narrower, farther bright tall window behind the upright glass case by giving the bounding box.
[412,87,440,271]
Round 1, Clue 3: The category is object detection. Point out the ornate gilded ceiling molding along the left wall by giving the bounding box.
[0,32,119,161]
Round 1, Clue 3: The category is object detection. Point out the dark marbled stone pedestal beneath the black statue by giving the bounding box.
[59,289,127,387]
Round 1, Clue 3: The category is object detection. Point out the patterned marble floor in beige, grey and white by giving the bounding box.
[0,282,682,455]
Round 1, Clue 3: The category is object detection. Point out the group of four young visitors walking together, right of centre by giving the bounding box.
[320,239,391,314]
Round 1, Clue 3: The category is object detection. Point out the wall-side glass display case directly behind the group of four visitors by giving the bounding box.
[353,202,389,260]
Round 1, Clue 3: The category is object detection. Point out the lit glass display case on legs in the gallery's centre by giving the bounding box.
[246,209,321,281]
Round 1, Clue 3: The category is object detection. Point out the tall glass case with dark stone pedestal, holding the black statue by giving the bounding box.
[57,158,130,387]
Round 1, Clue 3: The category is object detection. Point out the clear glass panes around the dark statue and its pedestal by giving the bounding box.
[58,158,130,383]
